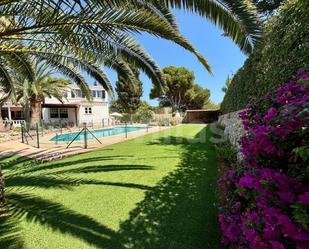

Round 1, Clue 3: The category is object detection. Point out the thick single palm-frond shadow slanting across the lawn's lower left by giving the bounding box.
[8,193,122,249]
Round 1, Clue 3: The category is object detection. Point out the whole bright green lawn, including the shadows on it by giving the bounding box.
[0,125,220,249]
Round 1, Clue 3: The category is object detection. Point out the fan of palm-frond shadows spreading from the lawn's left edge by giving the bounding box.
[0,155,152,249]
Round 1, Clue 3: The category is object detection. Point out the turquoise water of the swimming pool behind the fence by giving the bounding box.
[50,126,146,142]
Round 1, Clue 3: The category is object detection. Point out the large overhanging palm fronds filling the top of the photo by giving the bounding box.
[0,0,260,93]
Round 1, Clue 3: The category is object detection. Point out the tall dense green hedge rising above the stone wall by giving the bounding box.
[221,0,309,113]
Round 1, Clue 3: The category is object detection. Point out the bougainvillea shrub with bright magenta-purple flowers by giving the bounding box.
[219,71,309,249]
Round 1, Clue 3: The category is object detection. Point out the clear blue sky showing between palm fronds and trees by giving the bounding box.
[102,11,246,105]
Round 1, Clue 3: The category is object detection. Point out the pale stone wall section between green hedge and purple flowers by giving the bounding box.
[218,110,245,150]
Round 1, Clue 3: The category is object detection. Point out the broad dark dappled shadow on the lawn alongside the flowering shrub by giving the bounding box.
[120,126,221,249]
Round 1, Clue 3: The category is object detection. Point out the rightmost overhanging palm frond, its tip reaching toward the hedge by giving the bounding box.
[164,0,261,53]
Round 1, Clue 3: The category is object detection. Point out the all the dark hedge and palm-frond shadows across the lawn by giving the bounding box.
[0,126,221,249]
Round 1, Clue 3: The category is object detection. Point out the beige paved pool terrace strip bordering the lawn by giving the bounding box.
[0,127,168,161]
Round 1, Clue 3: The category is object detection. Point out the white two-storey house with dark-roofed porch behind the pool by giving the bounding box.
[1,84,109,126]
